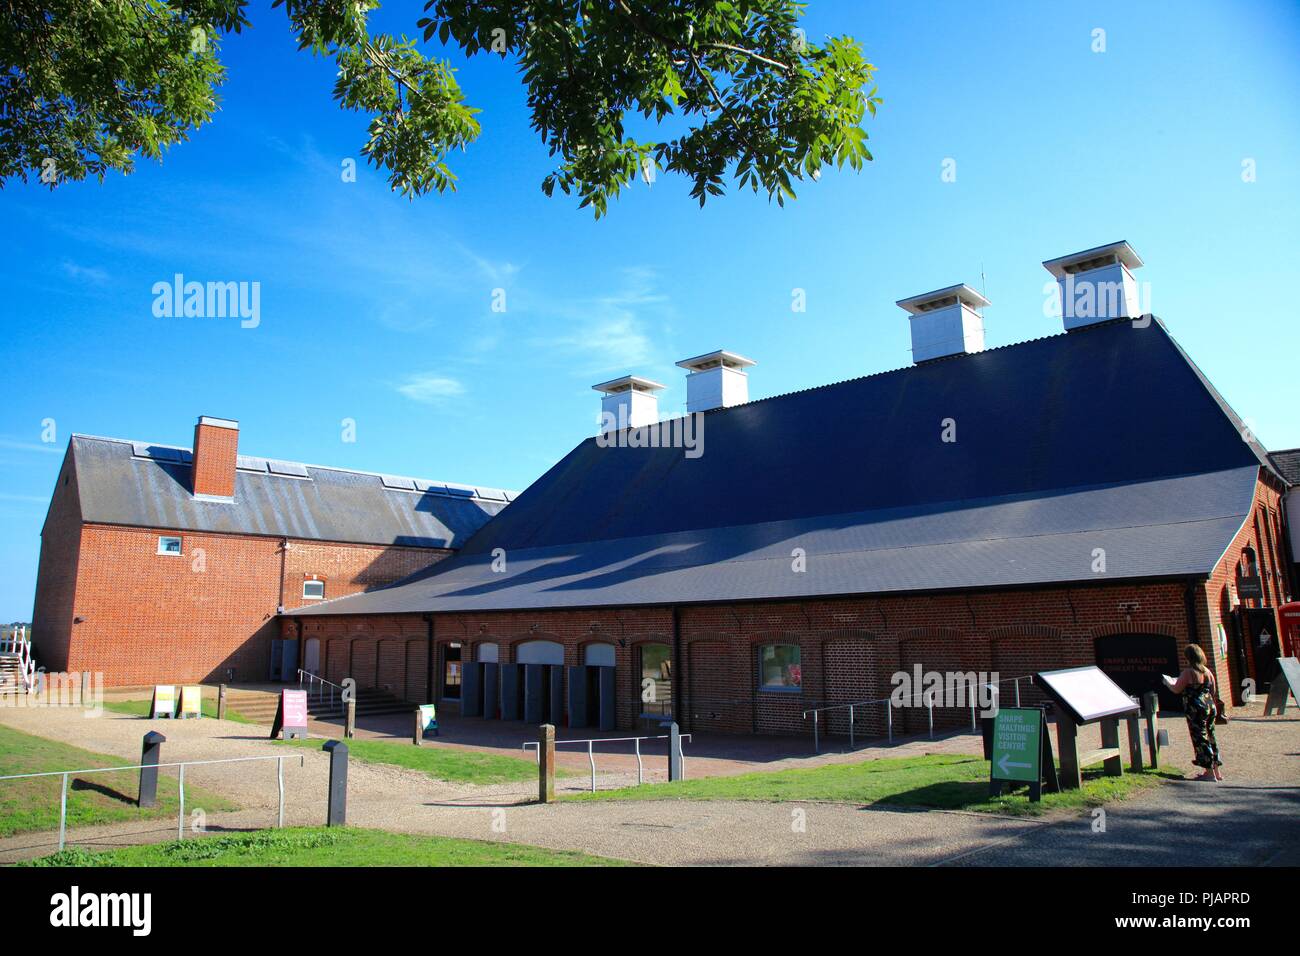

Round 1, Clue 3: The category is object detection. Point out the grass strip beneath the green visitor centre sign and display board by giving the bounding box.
[566,753,1182,814]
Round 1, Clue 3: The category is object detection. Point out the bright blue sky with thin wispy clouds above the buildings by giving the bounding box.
[0,0,1300,622]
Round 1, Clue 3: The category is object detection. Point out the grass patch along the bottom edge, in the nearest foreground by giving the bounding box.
[23,827,632,866]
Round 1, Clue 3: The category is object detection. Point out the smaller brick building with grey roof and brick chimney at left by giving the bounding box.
[34,419,506,687]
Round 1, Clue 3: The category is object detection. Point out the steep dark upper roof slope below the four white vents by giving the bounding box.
[468,321,1258,553]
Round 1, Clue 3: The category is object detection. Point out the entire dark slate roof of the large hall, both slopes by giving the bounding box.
[295,314,1271,614]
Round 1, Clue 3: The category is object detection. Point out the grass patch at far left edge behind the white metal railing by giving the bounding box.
[0,724,233,836]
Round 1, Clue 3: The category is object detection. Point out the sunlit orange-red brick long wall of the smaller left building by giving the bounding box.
[54,525,449,693]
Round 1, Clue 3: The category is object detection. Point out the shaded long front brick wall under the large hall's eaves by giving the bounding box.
[282,581,1205,734]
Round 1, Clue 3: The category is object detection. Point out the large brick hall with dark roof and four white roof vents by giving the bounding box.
[282,243,1294,734]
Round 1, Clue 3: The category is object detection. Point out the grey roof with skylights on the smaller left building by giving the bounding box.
[69,434,511,548]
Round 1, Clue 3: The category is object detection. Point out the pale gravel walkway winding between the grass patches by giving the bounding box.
[0,708,1300,865]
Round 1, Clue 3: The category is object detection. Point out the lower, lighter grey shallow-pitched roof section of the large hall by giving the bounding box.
[291,467,1257,614]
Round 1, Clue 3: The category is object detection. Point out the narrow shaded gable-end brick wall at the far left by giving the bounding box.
[31,446,81,671]
